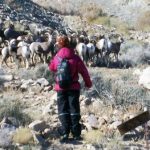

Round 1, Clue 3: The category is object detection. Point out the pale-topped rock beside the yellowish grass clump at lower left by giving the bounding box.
[29,120,48,132]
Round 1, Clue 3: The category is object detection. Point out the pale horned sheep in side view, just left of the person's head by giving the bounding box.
[29,33,54,64]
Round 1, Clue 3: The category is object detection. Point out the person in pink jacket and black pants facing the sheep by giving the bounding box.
[49,36,92,142]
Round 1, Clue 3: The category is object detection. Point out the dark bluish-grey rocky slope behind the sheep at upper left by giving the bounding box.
[0,0,71,33]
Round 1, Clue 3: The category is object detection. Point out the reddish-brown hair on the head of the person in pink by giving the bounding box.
[57,35,69,47]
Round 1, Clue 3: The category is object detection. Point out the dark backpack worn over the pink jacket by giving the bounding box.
[56,56,72,89]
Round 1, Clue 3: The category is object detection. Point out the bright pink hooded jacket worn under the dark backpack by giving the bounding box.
[49,47,92,91]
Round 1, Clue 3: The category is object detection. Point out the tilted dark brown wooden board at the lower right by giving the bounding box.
[117,111,150,135]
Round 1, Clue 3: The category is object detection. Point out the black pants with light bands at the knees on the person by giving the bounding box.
[57,90,81,136]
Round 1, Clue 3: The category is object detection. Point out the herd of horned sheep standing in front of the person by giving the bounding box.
[0,25,124,68]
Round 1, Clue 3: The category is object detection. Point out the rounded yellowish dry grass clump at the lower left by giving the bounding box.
[13,128,34,144]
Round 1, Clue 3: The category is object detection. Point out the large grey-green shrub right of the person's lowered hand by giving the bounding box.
[88,73,146,106]
